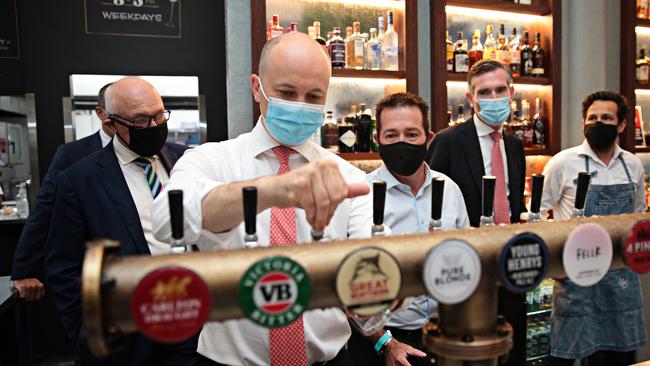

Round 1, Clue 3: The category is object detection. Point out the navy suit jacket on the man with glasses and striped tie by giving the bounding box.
[45,142,187,348]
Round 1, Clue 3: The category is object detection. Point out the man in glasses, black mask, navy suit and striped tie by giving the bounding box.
[46,77,199,365]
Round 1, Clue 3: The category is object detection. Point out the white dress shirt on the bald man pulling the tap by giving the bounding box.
[153,120,372,365]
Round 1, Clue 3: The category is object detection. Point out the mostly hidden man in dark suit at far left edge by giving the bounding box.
[11,84,113,301]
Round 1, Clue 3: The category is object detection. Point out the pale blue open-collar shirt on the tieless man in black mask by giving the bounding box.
[368,165,469,330]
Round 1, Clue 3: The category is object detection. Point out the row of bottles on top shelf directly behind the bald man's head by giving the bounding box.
[266,11,399,70]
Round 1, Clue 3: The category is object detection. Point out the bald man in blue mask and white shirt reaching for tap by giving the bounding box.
[152,33,372,365]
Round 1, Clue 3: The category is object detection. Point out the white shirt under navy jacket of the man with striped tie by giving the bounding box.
[112,136,171,255]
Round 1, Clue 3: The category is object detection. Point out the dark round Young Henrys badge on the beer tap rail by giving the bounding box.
[499,233,549,293]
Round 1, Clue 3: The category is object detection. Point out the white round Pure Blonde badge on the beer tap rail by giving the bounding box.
[422,239,481,304]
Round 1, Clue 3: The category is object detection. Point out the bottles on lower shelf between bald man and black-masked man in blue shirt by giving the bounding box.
[314,103,379,153]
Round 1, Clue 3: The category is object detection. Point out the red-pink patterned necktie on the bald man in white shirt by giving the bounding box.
[269,146,307,366]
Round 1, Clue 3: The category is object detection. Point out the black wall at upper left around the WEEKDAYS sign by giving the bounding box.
[0,0,228,177]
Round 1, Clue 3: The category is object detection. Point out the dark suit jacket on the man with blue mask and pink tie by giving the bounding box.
[428,118,526,226]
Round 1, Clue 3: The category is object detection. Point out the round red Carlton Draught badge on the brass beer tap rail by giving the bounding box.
[131,267,212,343]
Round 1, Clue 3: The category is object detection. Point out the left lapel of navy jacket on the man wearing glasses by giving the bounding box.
[97,141,151,254]
